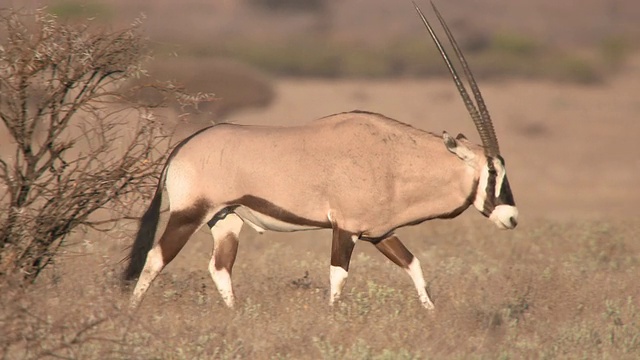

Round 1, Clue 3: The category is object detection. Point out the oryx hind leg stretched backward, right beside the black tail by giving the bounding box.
[131,205,207,308]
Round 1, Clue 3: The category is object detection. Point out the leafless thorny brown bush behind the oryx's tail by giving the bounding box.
[0,10,211,280]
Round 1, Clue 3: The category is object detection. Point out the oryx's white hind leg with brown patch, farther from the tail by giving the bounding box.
[209,213,243,308]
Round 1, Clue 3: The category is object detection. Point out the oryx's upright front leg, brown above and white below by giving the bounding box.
[329,221,358,305]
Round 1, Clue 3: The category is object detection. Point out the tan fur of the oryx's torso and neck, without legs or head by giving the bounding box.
[167,112,483,238]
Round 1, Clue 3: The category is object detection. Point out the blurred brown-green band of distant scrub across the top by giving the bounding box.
[15,0,640,105]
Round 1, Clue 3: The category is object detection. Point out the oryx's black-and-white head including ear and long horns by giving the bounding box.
[414,3,518,229]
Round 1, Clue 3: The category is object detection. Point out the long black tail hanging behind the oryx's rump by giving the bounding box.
[122,186,162,284]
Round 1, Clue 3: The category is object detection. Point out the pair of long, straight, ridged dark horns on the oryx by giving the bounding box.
[413,2,500,156]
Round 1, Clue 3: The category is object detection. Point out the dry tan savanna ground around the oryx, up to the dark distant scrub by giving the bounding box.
[0,1,640,359]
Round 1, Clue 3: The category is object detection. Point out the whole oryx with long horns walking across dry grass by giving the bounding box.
[125,4,518,309]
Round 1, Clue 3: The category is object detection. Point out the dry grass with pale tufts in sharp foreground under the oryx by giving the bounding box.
[0,217,640,359]
